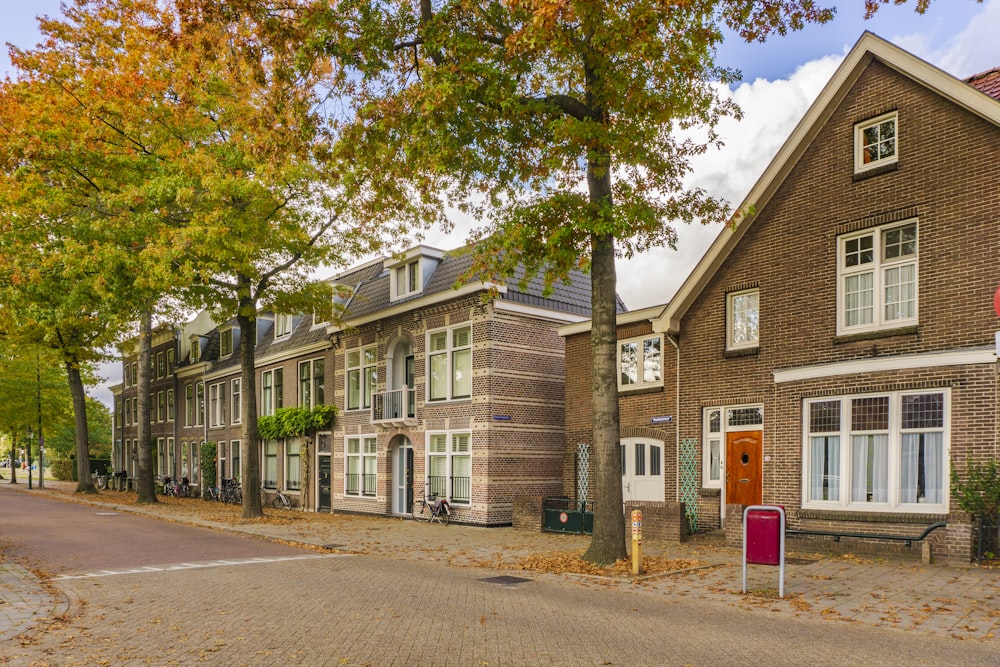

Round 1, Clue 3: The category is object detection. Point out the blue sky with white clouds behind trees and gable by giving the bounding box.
[0,0,1000,401]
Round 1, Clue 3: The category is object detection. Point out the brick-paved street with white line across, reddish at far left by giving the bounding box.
[0,494,1000,667]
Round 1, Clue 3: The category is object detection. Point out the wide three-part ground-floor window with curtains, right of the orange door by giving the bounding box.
[802,389,950,513]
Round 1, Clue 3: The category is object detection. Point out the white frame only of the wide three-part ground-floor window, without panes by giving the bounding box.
[802,388,951,514]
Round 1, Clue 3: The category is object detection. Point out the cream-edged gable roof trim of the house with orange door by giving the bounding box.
[653,31,1000,332]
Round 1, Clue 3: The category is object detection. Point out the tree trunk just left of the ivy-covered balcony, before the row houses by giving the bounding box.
[236,296,264,519]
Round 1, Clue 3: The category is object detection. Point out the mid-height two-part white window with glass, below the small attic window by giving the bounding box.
[837,220,918,335]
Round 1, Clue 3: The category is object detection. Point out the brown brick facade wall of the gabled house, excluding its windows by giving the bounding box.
[679,61,1000,562]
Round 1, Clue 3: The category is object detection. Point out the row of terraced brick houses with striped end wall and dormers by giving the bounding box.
[115,246,590,525]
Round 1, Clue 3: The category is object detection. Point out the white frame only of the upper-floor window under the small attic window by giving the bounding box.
[837,218,920,335]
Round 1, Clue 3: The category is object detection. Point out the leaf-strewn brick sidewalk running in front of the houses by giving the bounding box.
[7,482,1000,641]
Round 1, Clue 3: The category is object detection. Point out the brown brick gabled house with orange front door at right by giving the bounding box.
[564,33,1000,562]
